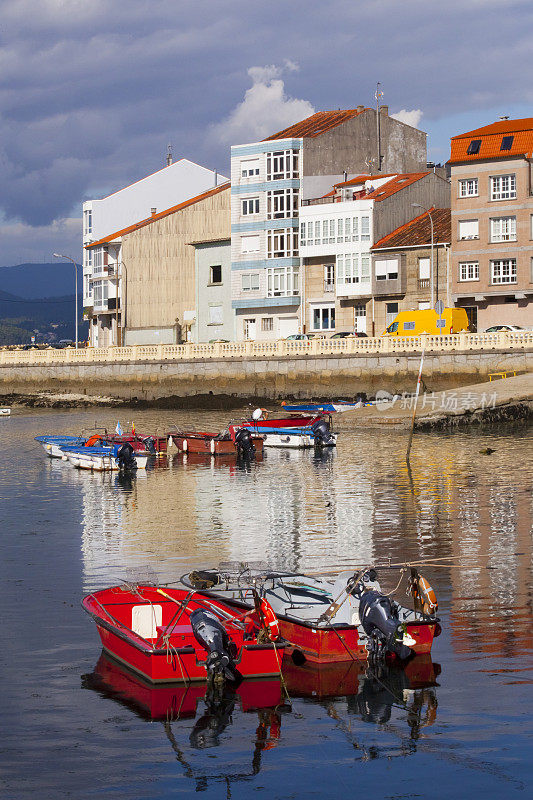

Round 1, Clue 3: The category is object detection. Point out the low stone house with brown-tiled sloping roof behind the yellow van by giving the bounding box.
[371,208,451,336]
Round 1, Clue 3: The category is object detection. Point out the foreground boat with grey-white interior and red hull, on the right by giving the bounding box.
[181,564,440,663]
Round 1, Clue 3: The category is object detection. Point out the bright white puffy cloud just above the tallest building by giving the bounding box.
[209,60,315,144]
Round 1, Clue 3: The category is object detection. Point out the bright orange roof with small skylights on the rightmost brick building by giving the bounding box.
[448,117,533,164]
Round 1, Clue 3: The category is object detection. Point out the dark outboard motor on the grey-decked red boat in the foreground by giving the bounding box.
[350,569,414,660]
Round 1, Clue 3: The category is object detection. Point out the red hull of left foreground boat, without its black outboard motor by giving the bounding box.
[82,586,283,683]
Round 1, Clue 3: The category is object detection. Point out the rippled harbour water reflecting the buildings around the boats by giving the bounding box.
[0,410,533,800]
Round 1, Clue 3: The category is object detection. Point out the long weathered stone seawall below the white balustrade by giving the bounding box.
[0,350,533,403]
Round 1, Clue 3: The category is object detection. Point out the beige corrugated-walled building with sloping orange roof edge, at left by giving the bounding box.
[86,182,230,346]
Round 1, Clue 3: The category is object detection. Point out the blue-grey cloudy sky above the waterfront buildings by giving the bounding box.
[0,0,533,266]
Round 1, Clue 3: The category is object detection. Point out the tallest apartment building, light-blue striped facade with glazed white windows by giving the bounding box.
[231,106,426,340]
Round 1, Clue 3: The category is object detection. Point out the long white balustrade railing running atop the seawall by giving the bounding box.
[0,331,533,366]
